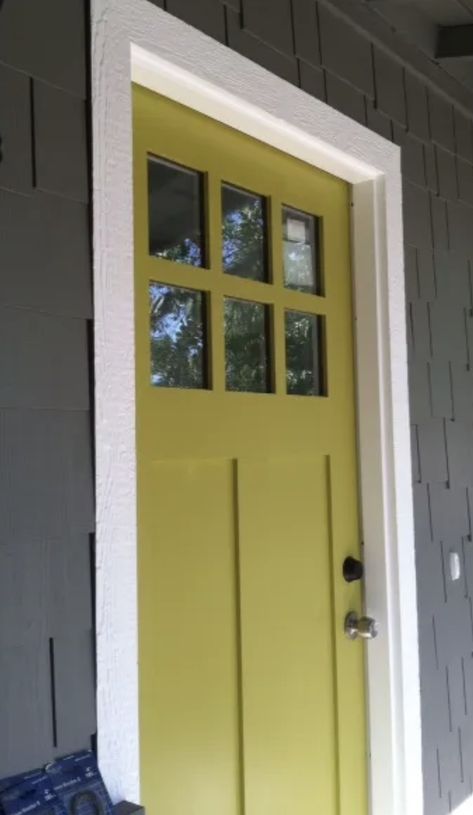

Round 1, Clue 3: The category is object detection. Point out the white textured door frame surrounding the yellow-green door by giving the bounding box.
[92,0,423,815]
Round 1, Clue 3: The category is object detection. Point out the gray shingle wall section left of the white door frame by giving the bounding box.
[0,0,95,778]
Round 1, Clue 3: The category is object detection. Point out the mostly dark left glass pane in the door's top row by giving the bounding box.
[148,157,205,266]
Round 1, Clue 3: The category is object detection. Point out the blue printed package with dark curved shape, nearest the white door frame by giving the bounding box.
[44,750,113,815]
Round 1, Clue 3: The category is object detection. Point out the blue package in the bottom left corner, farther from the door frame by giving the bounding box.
[0,772,67,815]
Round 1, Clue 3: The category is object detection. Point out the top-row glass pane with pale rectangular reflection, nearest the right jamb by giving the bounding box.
[282,207,321,294]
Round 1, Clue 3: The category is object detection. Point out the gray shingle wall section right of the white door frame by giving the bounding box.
[148,0,473,815]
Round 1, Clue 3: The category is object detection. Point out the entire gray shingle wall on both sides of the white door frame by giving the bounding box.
[0,0,473,815]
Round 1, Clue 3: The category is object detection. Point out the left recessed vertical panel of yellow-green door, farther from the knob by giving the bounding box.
[140,459,240,815]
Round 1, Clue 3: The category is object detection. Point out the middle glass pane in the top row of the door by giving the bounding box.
[222,184,268,281]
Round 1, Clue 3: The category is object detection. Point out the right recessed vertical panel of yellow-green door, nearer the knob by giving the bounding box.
[238,457,337,815]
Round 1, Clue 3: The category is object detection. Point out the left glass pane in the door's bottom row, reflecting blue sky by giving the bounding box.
[149,282,208,388]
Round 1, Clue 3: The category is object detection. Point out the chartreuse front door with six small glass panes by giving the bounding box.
[133,87,367,815]
